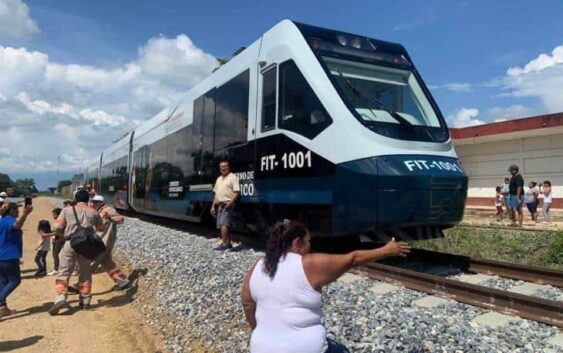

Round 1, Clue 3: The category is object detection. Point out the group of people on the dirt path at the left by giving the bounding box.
[0,184,130,318]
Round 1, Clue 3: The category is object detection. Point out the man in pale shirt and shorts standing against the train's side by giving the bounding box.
[211,160,240,251]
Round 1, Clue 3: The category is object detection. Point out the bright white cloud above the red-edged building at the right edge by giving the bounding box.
[503,45,563,112]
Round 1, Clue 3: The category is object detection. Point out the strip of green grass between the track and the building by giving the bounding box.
[413,226,563,270]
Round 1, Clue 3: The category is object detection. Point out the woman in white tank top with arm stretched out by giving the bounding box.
[241,219,410,353]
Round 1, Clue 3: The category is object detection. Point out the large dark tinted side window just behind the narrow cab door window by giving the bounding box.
[215,70,249,151]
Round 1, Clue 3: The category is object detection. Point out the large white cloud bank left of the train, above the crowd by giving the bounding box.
[0,34,217,180]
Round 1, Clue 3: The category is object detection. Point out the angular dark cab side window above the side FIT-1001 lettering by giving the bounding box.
[278,60,332,139]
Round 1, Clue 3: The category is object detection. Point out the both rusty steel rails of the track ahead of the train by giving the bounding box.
[360,249,563,329]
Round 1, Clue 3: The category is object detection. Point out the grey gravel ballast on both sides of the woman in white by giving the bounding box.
[111,210,558,353]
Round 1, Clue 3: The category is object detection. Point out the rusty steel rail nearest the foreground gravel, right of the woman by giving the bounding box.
[362,263,563,329]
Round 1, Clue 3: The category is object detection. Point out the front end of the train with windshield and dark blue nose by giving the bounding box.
[270,24,468,240]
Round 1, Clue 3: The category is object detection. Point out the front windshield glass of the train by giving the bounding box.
[322,56,441,128]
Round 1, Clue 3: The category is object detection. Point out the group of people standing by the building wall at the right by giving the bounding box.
[495,164,553,227]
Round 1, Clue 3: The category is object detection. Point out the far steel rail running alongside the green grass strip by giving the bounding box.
[409,249,563,288]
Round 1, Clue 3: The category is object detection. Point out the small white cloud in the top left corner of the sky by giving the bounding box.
[0,0,40,38]
